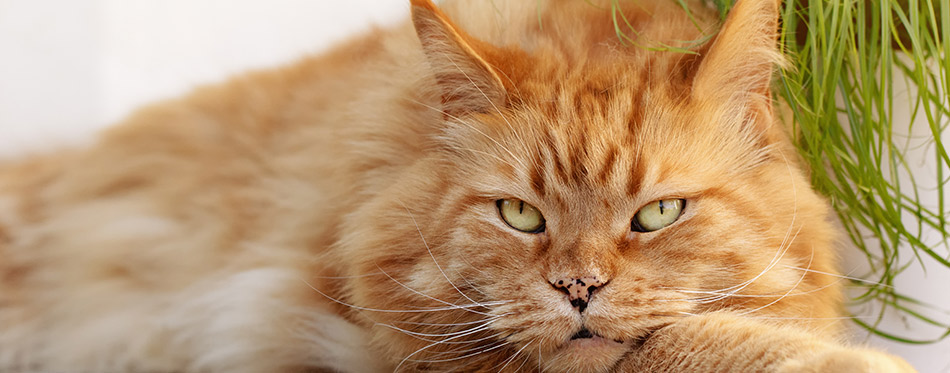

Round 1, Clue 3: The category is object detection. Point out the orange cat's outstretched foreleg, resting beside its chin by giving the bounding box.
[618,312,915,372]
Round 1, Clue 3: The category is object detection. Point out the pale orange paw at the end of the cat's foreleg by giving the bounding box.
[777,347,917,373]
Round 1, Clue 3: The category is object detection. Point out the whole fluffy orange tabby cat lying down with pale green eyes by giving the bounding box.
[0,0,913,372]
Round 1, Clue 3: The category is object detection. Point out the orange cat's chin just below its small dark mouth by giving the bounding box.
[542,336,635,372]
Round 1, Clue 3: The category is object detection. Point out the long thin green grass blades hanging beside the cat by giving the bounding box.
[776,0,950,343]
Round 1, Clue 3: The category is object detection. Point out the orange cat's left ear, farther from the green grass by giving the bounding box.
[412,0,506,116]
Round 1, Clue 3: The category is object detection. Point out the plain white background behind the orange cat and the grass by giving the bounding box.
[0,0,950,372]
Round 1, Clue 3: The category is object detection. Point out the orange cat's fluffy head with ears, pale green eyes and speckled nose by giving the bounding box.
[341,0,836,371]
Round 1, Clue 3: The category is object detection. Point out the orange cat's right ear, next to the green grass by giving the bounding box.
[693,0,782,116]
